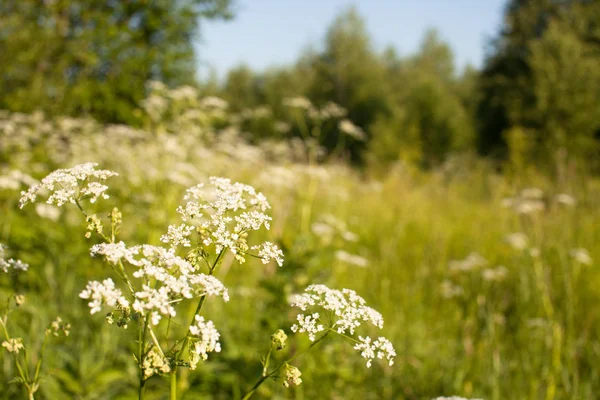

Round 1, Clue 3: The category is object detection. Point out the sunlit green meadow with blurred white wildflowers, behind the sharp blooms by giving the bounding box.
[0,88,600,400]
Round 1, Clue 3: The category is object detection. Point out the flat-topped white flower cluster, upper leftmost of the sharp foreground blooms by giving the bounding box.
[19,163,118,208]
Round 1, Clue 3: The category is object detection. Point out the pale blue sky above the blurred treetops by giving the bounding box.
[197,0,506,77]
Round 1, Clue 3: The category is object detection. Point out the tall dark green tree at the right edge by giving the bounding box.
[477,0,600,164]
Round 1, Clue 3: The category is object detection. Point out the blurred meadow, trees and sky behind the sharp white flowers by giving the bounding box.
[0,0,600,400]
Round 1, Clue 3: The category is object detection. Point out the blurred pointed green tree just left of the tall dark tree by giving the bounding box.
[370,30,473,167]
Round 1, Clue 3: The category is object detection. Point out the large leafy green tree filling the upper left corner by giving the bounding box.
[0,0,230,122]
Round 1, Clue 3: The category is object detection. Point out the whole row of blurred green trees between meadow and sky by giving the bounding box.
[0,0,600,168]
